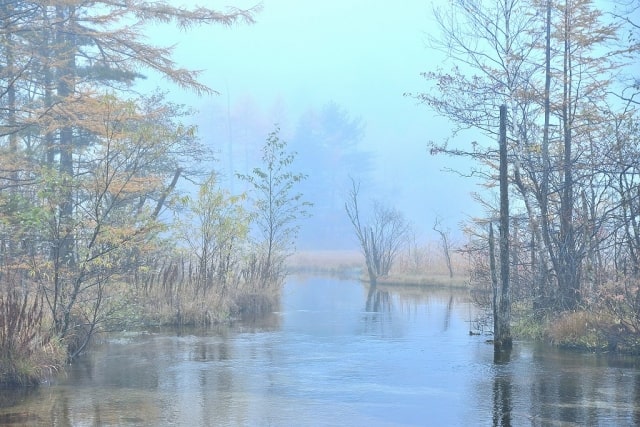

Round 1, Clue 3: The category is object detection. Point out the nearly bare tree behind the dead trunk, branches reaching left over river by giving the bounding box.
[416,1,549,318]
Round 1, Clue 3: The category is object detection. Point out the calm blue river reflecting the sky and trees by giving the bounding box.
[0,277,640,426]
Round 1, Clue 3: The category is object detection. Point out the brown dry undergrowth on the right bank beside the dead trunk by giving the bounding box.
[465,232,640,354]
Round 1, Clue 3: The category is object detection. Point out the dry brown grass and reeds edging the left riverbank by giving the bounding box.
[0,274,282,388]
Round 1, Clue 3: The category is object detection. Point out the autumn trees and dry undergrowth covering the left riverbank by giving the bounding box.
[0,1,308,384]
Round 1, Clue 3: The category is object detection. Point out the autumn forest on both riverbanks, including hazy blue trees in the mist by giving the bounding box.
[0,0,640,384]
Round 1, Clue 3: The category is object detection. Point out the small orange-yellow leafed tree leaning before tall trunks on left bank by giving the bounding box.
[35,95,205,357]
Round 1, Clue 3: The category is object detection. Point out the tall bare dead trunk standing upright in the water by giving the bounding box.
[491,105,512,352]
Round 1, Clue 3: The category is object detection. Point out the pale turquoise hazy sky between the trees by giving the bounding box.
[141,0,479,244]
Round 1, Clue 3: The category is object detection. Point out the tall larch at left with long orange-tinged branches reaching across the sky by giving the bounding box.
[40,1,252,263]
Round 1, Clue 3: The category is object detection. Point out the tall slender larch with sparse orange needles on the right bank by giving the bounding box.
[545,0,619,309]
